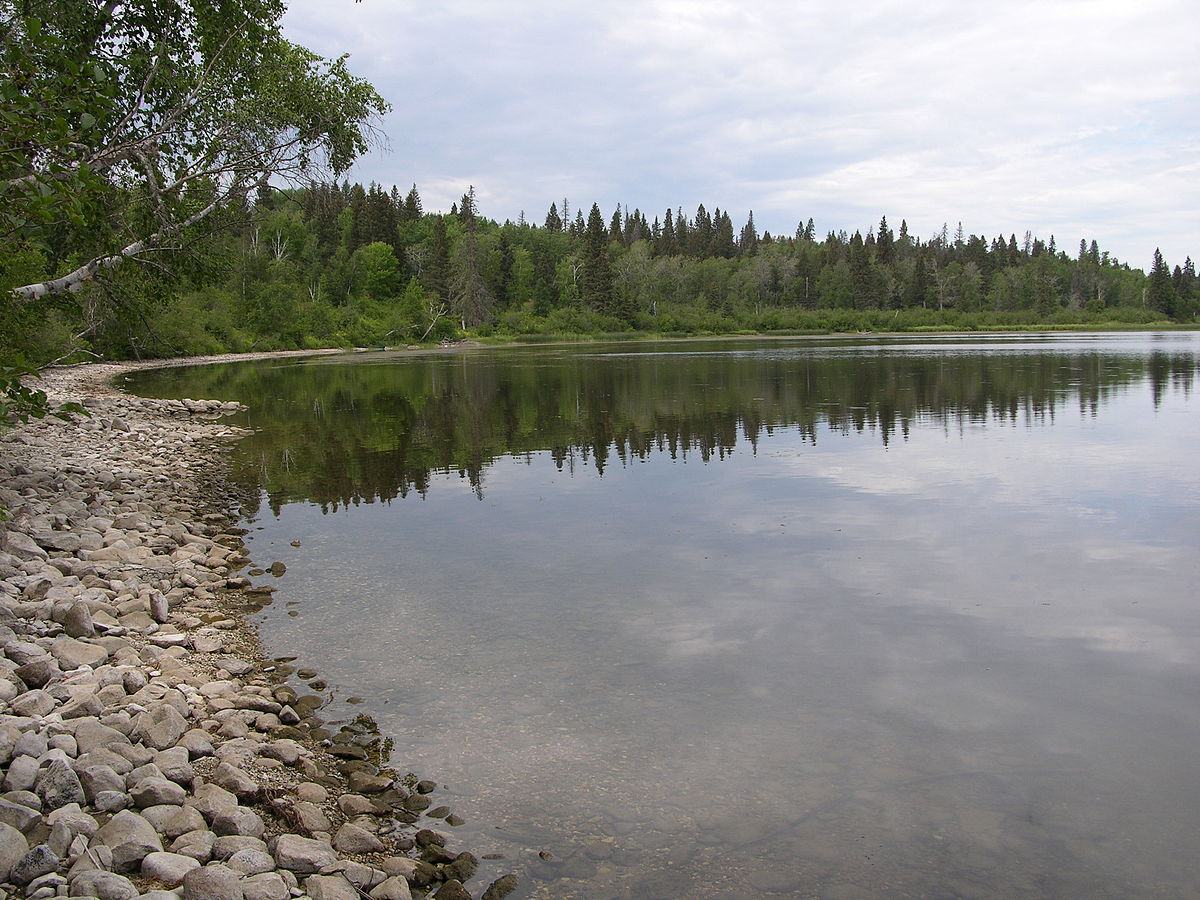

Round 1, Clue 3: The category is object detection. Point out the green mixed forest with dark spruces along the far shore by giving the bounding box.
[14,182,1200,358]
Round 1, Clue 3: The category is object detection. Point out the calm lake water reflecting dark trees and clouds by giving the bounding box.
[134,334,1200,900]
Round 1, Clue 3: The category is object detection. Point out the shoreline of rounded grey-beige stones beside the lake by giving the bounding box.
[0,360,516,900]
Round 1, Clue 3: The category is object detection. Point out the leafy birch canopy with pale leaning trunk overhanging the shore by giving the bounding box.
[0,0,388,302]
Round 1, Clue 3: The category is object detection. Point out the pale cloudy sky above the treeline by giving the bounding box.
[283,0,1200,270]
